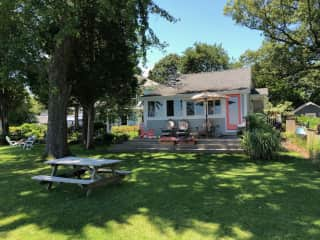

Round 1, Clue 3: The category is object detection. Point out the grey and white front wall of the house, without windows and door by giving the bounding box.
[143,90,249,135]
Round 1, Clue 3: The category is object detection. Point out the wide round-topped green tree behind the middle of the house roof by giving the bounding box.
[181,43,229,73]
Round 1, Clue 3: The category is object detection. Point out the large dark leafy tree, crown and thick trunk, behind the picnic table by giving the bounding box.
[19,0,175,157]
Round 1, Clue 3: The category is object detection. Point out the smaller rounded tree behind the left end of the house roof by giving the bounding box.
[149,54,181,84]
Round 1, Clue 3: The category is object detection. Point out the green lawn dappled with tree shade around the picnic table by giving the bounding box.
[0,146,320,240]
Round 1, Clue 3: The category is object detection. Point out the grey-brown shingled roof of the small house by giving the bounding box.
[144,68,252,96]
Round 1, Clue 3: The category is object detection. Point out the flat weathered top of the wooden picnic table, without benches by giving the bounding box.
[45,157,121,167]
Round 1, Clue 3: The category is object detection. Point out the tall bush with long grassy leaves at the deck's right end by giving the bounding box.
[241,114,281,160]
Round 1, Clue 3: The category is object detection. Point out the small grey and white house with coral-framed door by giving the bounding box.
[142,68,268,135]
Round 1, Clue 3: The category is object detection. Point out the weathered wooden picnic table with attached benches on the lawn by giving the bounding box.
[32,157,131,196]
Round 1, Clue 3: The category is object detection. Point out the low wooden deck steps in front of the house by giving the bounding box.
[109,138,243,153]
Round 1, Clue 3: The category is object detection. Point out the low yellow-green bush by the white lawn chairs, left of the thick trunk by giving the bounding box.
[9,123,47,140]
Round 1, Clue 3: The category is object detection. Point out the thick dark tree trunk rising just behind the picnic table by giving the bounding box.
[46,38,72,158]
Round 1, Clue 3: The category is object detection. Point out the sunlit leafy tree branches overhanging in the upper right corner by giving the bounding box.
[225,0,320,72]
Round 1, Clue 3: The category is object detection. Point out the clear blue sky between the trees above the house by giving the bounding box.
[147,0,263,68]
